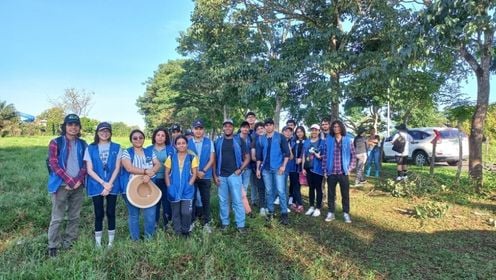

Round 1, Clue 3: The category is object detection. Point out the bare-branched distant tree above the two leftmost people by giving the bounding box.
[49,88,95,116]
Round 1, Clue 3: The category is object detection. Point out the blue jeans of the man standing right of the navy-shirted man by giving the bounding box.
[262,169,288,214]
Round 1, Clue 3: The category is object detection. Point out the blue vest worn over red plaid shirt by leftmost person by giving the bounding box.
[48,135,88,193]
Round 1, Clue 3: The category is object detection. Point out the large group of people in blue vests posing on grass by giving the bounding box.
[48,112,380,256]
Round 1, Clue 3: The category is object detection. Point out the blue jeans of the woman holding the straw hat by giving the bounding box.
[122,194,157,240]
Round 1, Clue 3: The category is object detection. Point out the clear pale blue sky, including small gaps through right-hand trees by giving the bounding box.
[0,0,496,128]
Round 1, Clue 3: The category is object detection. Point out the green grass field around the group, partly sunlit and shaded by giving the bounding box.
[0,137,496,279]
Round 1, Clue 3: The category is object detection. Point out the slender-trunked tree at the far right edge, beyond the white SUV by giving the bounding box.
[421,0,496,192]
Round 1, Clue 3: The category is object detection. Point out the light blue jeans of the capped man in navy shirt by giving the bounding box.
[218,174,245,228]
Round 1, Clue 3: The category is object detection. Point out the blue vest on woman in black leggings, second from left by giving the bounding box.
[86,142,121,197]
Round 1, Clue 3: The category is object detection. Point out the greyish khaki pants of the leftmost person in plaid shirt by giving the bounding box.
[48,186,84,248]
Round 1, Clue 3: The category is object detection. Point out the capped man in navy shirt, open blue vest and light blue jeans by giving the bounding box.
[214,119,250,233]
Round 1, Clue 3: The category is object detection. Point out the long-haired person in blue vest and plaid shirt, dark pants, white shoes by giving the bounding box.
[325,121,356,223]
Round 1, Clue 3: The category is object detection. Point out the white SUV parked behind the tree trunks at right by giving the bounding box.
[384,127,468,166]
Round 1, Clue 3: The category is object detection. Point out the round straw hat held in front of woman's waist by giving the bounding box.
[126,175,162,208]
